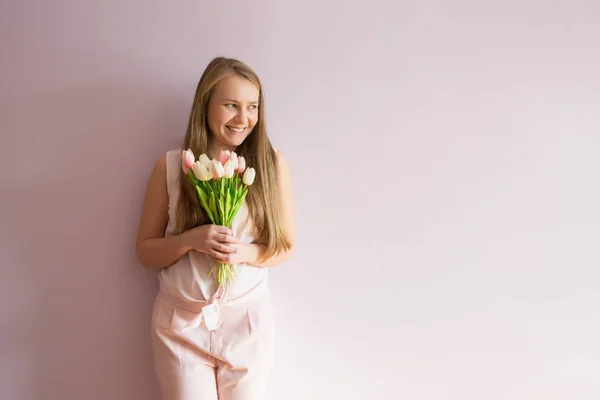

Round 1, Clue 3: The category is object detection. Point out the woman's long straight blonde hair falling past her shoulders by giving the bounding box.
[176,57,291,261]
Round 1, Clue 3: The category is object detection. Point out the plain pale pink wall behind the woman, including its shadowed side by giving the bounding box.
[0,0,600,400]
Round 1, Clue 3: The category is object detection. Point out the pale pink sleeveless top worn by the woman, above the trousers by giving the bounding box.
[159,149,268,302]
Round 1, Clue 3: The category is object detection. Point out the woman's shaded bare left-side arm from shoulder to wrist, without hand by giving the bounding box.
[136,154,191,268]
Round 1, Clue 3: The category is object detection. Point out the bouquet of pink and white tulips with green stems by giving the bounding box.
[181,149,256,288]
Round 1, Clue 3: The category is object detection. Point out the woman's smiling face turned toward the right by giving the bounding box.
[208,75,260,157]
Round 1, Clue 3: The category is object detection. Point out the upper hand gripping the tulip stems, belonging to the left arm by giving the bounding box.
[183,224,240,262]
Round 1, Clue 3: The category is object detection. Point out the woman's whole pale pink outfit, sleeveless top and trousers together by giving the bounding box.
[152,150,274,400]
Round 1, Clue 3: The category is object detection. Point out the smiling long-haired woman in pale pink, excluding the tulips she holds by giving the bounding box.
[136,57,295,400]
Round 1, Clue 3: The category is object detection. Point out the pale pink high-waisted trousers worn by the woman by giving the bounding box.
[152,290,274,400]
